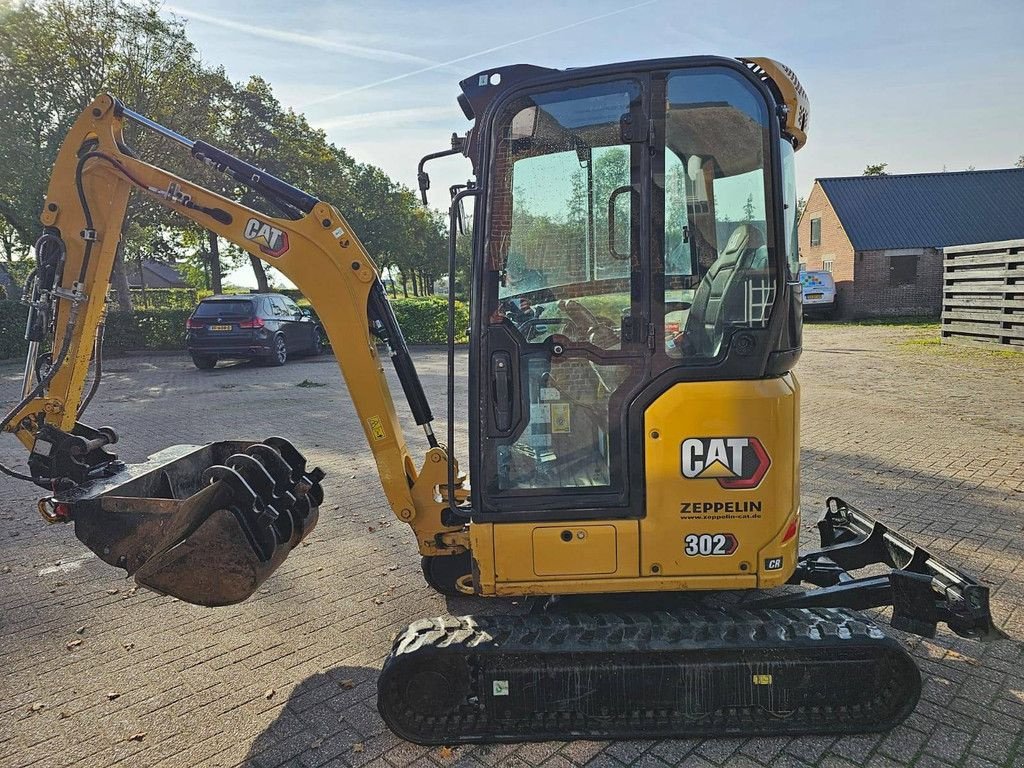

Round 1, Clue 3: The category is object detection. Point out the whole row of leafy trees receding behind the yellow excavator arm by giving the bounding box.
[0,0,446,309]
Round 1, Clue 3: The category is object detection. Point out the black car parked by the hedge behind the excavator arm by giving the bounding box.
[185,293,324,371]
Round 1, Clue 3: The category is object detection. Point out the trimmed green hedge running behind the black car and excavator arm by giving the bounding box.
[0,296,469,359]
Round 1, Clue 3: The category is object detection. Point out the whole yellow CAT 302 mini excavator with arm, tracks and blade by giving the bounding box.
[2,56,1000,744]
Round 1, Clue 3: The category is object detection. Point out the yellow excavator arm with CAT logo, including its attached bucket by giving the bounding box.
[2,95,467,605]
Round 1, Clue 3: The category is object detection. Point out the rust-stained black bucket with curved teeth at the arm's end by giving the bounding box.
[53,437,324,606]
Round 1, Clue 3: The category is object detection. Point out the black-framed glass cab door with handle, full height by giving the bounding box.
[470,77,651,520]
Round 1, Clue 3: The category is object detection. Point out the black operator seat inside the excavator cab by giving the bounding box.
[683,223,767,356]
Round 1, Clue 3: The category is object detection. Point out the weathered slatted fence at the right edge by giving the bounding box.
[942,240,1024,351]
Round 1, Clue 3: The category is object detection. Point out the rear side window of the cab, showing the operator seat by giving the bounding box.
[655,70,770,361]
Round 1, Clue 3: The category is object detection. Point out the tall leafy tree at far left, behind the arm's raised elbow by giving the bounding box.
[0,0,229,308]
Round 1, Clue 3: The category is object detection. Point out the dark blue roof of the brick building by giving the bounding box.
[817,168,1024,251]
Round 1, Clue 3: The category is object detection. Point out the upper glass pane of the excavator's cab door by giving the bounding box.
[488,76,640,349]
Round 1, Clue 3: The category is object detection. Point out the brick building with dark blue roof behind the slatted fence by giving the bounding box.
[799,168,1024,318]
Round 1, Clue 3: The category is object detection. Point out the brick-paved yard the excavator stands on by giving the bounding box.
[0,325,1024,768]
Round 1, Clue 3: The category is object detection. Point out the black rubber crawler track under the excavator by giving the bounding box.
[378,608,921,744]
